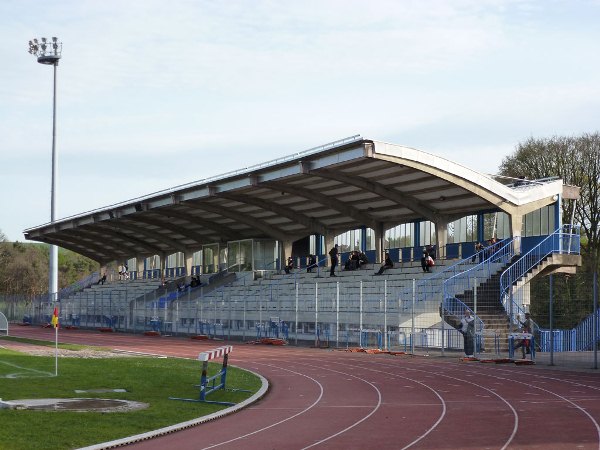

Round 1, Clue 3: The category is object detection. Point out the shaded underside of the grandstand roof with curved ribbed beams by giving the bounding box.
[26,140,540,263]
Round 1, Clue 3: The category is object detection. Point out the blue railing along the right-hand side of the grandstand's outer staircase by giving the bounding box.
[500,224,581,323]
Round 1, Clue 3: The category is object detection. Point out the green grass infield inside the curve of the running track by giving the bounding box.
[0,339,260,450]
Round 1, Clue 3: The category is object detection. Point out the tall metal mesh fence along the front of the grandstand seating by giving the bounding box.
[0,268,600,368]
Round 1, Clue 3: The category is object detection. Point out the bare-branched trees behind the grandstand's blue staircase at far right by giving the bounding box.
[500,132,600,329]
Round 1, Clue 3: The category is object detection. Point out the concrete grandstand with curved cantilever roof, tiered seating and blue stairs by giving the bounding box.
[19,135,581,353]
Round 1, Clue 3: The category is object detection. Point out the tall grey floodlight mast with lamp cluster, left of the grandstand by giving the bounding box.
[29,37,62,303]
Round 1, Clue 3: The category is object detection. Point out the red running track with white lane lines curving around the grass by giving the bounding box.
[5,327,600,450]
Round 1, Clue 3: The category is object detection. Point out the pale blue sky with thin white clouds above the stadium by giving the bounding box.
[0,0,600,241]
